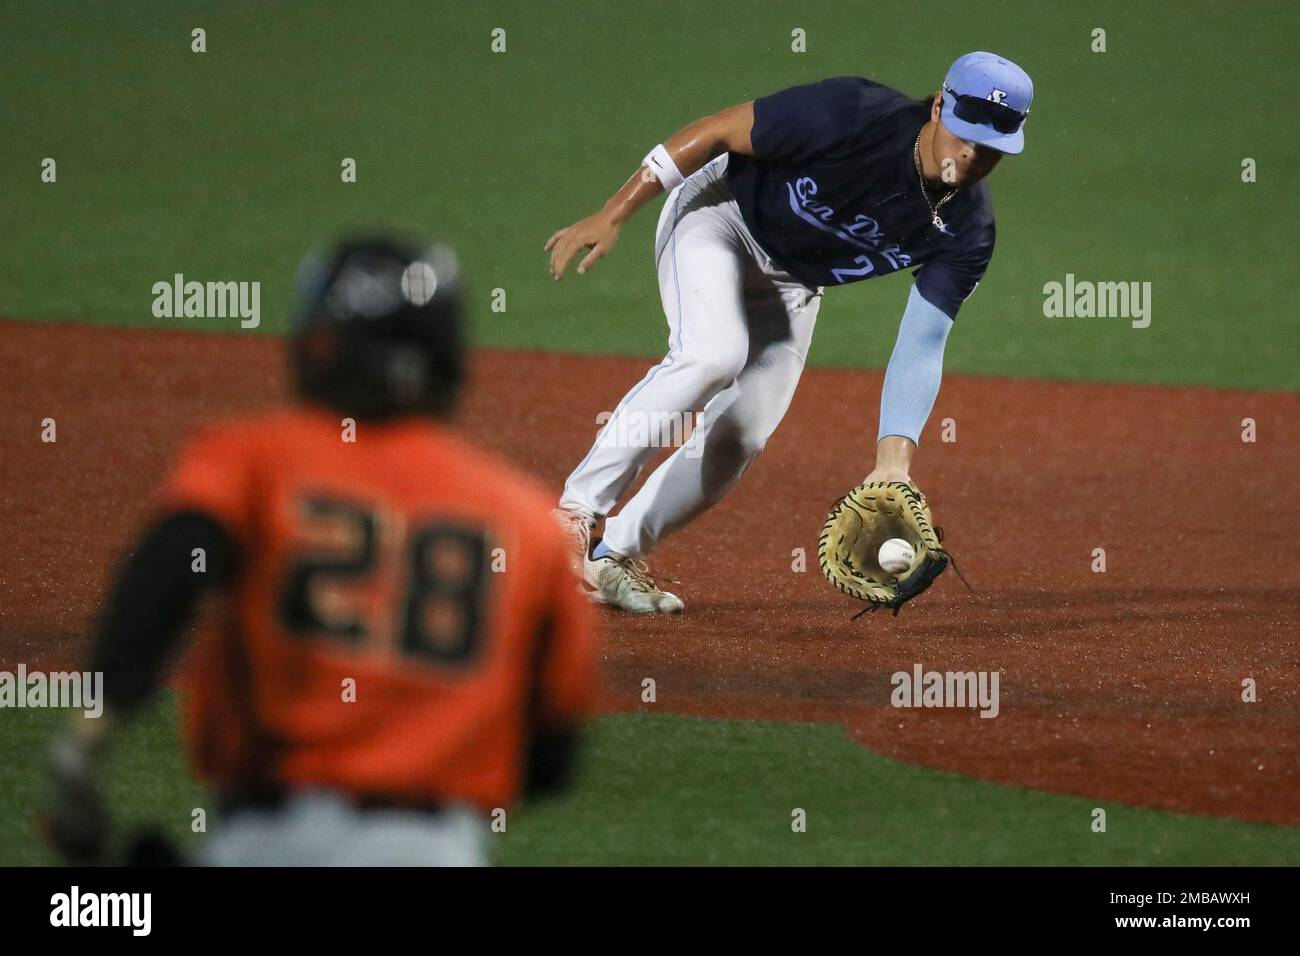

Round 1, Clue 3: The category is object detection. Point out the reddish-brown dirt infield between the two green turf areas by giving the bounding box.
[0,323,1300,825]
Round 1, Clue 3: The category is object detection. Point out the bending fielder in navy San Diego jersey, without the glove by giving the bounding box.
[546,53,1034,613]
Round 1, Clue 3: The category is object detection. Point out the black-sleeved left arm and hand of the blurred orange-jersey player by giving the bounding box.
[42,511,235,862]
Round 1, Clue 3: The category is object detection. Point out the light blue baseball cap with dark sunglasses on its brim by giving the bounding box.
[940,52,1034,153]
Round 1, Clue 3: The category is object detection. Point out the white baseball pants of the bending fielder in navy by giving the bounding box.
[560,153,822,557]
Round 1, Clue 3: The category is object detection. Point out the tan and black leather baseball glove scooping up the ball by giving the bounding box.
[818,481,969,618]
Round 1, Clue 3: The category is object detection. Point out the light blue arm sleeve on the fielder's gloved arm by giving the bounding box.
[876,286,953,445]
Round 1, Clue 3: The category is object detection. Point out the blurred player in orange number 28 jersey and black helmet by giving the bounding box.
[44,241,595,865]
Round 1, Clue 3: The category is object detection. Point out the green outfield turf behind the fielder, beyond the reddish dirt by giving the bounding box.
[0,0,1300,389]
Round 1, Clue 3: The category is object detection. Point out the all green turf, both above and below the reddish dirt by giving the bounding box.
[0,0,1300,865]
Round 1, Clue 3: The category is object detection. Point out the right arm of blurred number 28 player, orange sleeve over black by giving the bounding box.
[524,540,599,797]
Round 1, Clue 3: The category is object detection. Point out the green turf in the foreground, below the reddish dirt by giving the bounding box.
[0,697,1300,866]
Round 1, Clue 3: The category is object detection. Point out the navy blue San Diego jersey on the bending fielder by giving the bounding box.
[727,77,993,316]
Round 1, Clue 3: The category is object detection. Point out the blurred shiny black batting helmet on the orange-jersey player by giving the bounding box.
[290,238,464,419]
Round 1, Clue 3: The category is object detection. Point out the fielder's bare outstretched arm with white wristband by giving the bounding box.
[546,103,754,278]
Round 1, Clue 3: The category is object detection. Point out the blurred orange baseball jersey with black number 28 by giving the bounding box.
[161,408,597,809]
